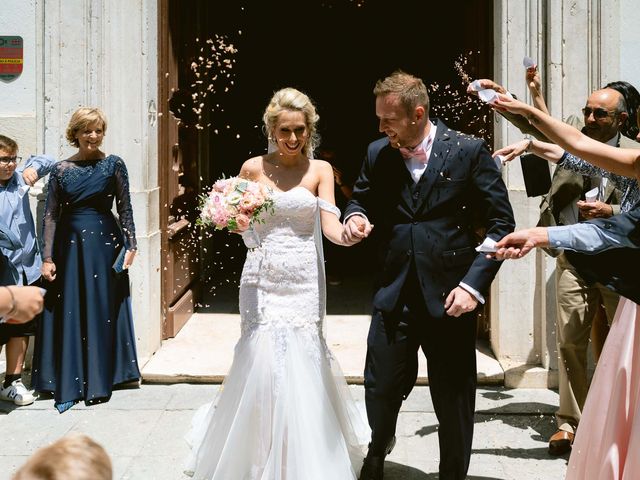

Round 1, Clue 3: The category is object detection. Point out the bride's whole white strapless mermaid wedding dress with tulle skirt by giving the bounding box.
[186,186,370,480]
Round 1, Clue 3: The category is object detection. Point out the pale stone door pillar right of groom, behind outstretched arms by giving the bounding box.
[491,0,543,366]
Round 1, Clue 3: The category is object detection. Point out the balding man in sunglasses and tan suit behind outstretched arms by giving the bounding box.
[470,74,640,455]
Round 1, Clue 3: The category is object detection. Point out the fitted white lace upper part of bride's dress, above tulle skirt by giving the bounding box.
[240,187,340,372]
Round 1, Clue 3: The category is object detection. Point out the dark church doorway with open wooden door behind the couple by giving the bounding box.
[159,0,493,336]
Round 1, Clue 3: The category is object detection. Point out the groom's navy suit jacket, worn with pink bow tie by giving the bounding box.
[345,120,514,318]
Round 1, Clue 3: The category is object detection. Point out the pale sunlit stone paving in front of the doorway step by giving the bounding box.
[0,384,567,480]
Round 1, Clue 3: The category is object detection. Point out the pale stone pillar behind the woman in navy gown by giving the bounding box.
[43,0,162,365]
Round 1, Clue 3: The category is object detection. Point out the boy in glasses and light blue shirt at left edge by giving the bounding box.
[0,135,55,406]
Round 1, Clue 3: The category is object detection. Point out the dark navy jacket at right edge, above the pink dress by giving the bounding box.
[566,203,640,303]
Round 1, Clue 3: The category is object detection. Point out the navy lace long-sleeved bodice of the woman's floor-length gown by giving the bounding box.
[43,155,136,258]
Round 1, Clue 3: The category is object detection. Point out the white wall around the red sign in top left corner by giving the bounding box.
[0,0,41,156]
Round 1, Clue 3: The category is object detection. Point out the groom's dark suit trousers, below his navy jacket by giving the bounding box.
[365,267,476,480]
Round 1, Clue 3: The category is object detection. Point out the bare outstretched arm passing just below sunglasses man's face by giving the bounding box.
[494,95,640,177]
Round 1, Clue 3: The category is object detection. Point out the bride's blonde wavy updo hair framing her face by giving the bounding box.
[262,87,320,157]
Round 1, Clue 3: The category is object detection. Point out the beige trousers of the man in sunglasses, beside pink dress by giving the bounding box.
[556,254,620,433]
